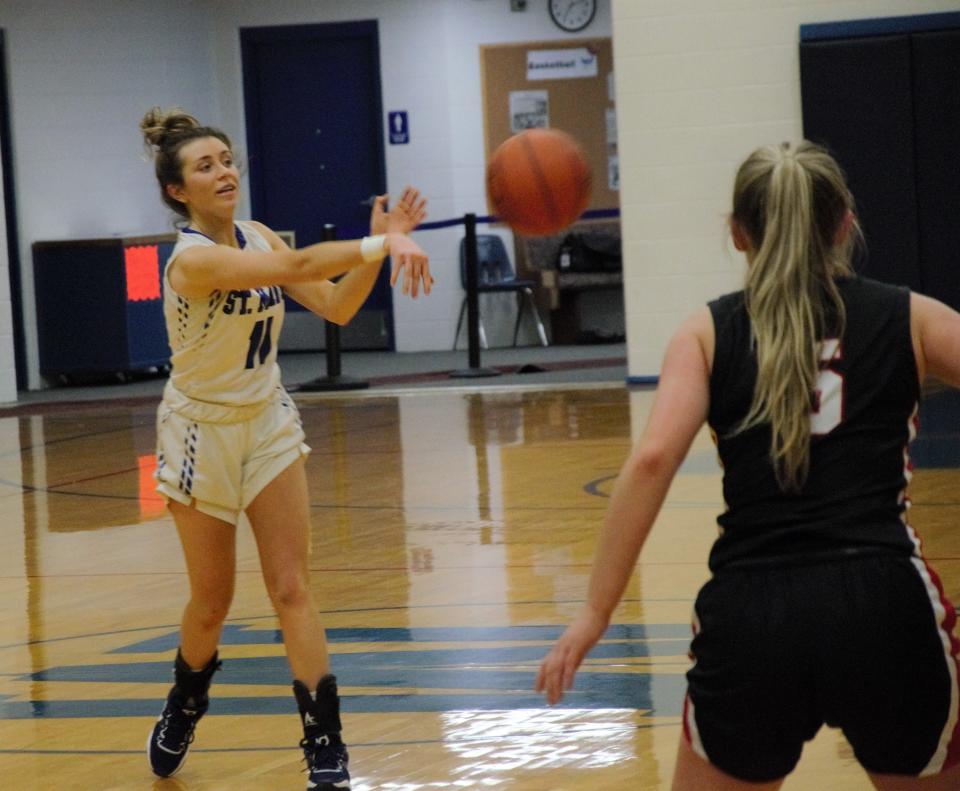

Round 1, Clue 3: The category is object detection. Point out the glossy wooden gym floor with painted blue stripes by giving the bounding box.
[0,384,960,791]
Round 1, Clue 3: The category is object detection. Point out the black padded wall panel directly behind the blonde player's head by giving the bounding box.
[800,35,924,291]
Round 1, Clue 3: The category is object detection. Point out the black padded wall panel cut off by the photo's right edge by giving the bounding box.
[910,30,960,309]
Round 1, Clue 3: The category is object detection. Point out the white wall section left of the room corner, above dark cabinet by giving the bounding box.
[0,0,219,401]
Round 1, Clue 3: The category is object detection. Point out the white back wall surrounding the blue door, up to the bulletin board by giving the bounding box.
[0,0,611,402]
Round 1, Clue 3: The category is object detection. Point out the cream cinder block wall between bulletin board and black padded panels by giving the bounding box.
[613,0,957,377]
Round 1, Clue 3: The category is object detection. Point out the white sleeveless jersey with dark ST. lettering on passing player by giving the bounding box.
[163,222,284,407]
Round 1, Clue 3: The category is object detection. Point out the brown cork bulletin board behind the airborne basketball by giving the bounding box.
[480,38,620,209]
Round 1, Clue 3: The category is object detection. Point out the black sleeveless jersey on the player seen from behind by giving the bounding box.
[709,277,920,570]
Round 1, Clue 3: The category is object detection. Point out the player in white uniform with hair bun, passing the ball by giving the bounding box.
[141,108,433,790]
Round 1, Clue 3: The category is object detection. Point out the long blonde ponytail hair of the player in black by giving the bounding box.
[732,141,853,492]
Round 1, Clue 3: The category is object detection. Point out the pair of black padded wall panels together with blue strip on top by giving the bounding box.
[800,12,960,309]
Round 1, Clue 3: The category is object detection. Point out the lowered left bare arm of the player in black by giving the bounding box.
[536,308,713,703]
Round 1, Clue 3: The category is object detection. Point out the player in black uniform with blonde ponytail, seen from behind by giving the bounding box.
[537,142,960,791]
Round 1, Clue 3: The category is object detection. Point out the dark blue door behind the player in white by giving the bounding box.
[240,22,393,349]
